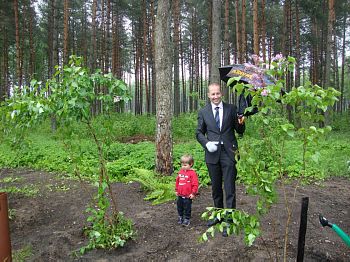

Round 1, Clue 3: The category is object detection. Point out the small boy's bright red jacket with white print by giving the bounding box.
[175,169,198,197]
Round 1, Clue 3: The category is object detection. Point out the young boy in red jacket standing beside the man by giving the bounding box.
[175,155,198,226]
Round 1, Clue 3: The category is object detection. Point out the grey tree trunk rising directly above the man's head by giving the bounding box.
[210,0,221,83]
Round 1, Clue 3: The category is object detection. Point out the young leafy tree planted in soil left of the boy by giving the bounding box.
[0,56,134,253]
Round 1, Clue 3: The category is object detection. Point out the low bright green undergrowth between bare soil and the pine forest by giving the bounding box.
[0,114,350,202]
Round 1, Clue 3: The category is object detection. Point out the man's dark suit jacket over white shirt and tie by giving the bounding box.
[196,102,245,164]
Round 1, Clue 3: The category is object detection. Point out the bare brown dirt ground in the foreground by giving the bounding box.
[0,169,350,262]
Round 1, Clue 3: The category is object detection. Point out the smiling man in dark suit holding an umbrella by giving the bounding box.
[196,83,245,230]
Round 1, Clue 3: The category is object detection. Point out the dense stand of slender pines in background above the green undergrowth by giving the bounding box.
[0,0,350,115]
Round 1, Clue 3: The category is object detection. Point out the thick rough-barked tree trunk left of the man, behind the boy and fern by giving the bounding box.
[155,0,173,175]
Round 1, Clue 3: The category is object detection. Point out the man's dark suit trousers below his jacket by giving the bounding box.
[207,146,237,208]
